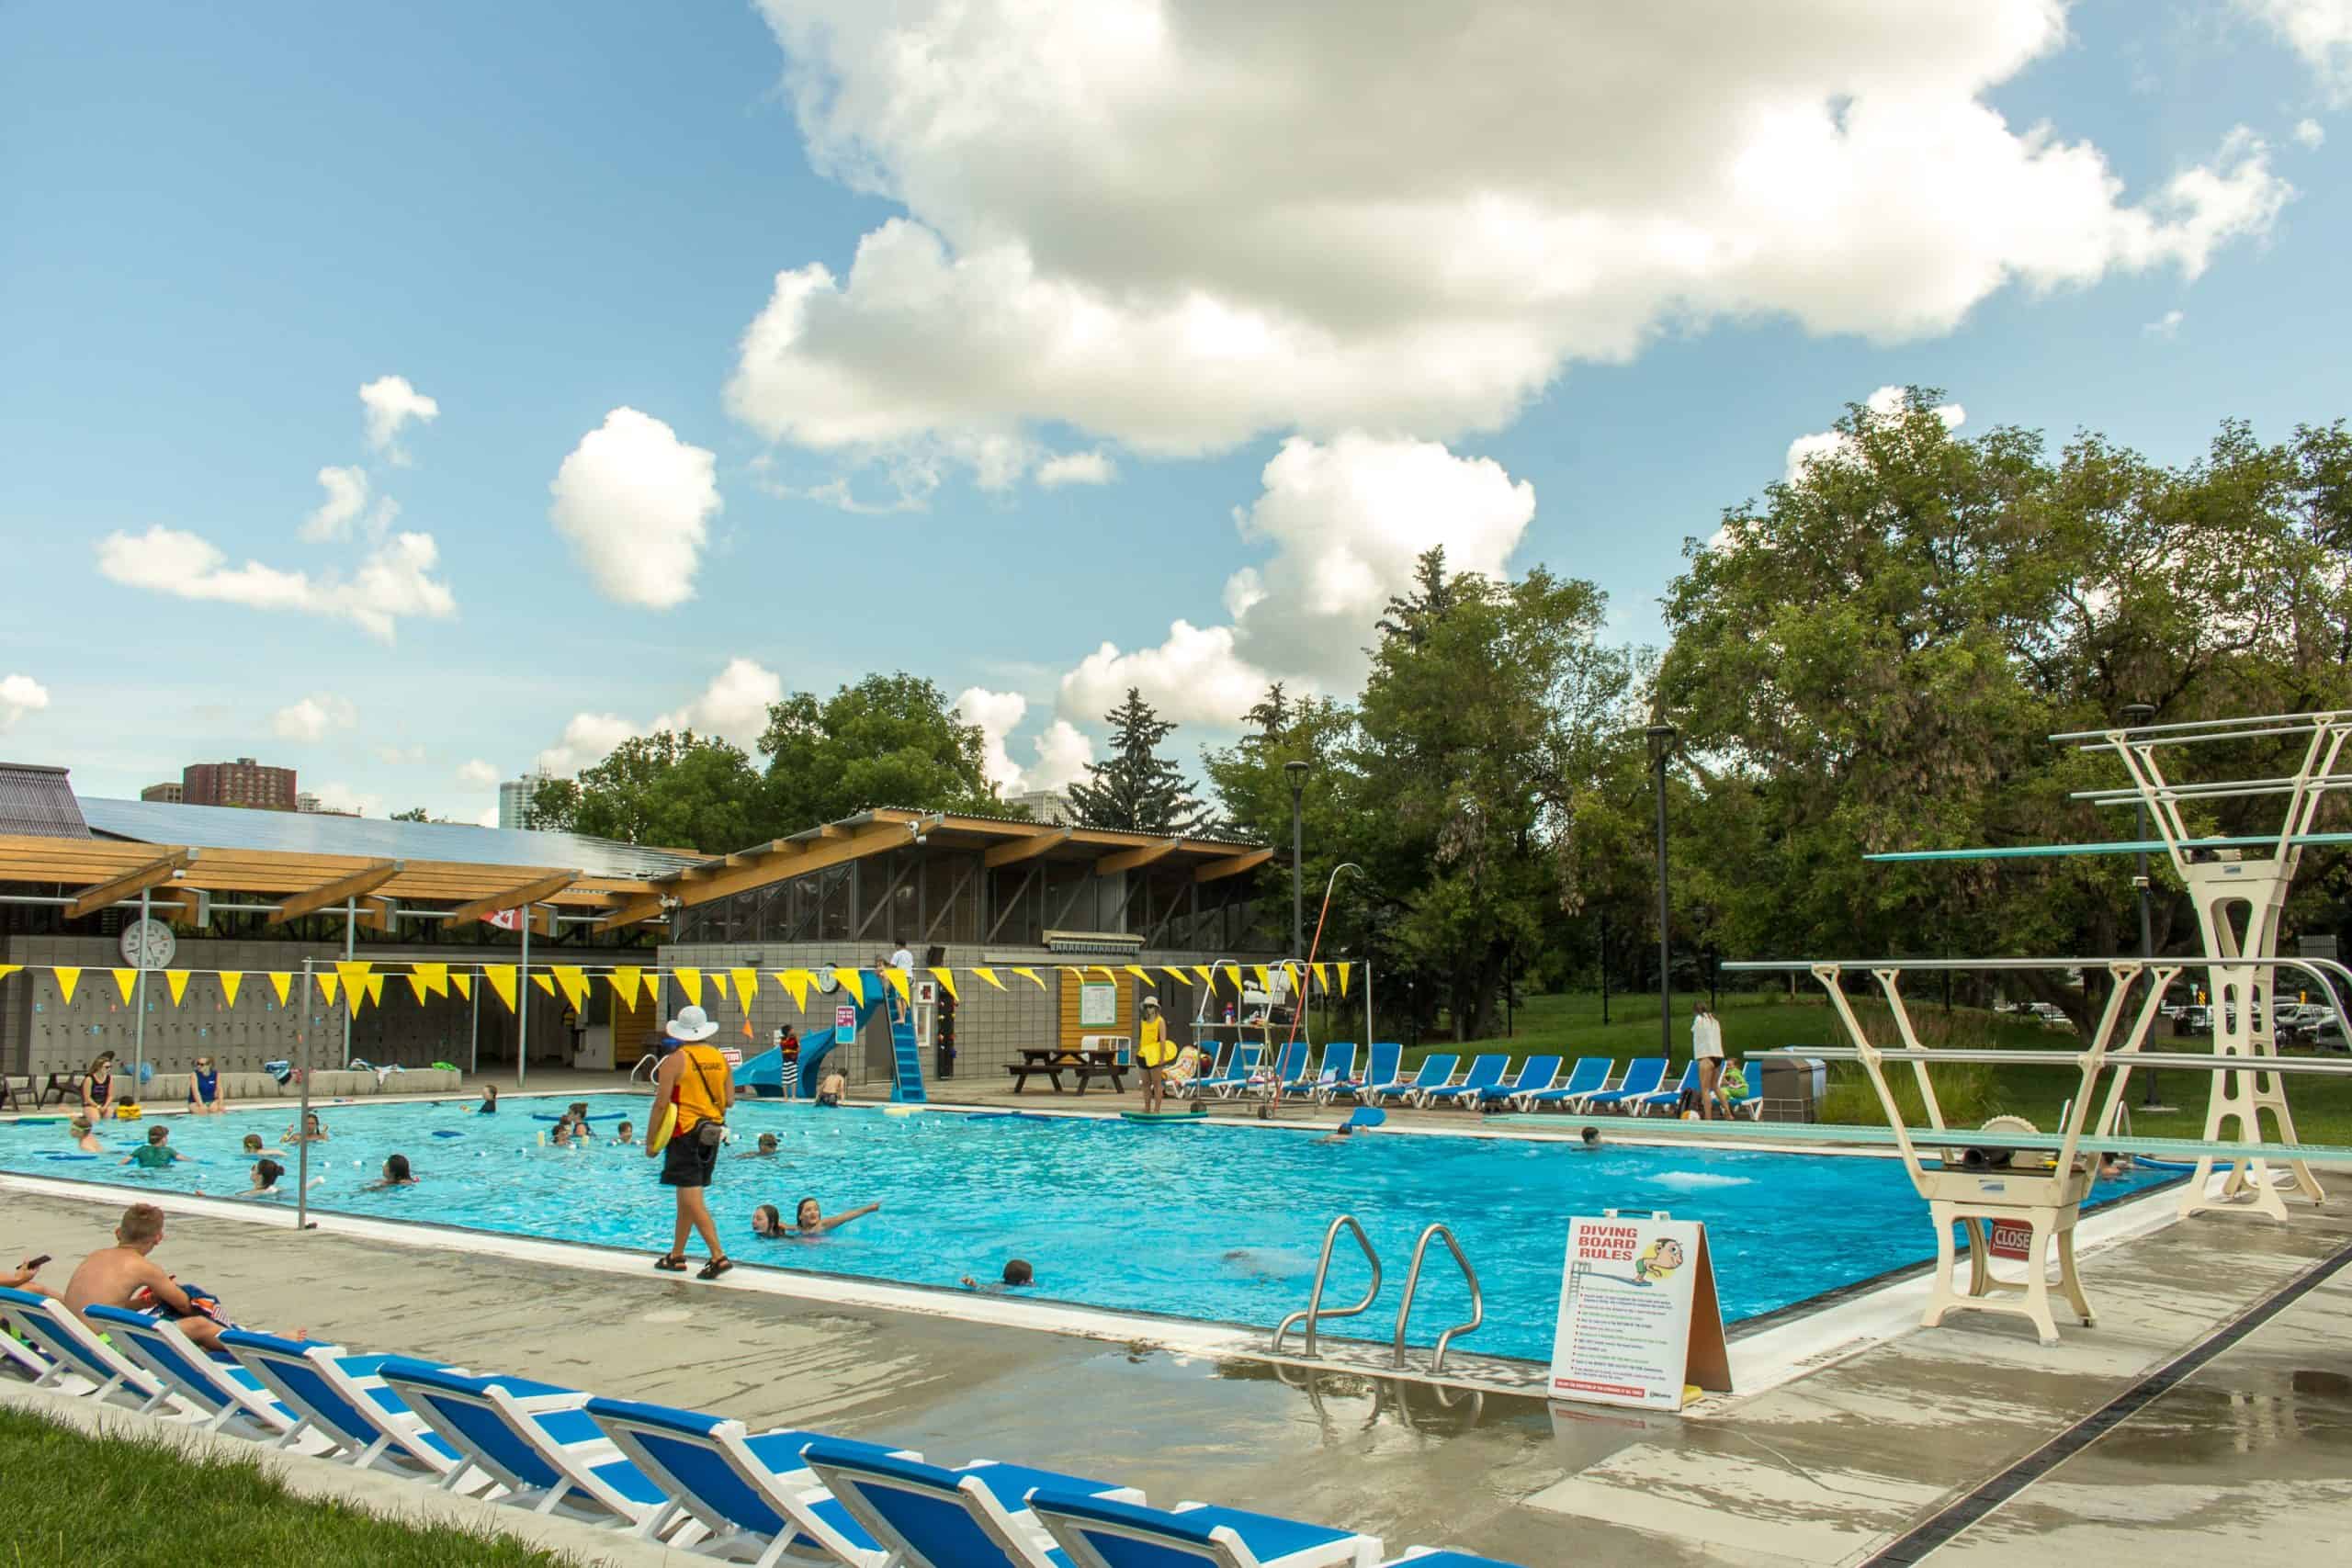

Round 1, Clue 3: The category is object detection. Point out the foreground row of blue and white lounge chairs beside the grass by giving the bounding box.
[0,1288,1510,1568]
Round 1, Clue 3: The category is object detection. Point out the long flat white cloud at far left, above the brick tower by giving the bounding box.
[99,525,457,642]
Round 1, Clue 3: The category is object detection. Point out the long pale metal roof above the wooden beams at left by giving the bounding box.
[75,799,696,879]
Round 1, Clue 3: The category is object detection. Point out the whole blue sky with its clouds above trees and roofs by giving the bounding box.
[0,0,2352,820]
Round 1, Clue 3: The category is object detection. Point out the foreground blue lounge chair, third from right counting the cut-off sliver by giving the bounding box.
[807,1441,1143,1568]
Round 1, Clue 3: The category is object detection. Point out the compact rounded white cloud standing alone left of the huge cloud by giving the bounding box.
[548,409,722,609]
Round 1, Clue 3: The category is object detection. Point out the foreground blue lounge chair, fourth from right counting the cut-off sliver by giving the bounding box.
[588,1399,922,1568]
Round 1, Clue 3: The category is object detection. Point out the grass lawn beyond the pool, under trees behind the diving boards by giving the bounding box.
[1374,980,2352,1147]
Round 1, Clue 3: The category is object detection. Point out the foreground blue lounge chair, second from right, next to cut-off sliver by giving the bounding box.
[1030,1491,1381,1568]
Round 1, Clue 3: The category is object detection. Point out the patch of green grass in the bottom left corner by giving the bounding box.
[0,1411,576,1568]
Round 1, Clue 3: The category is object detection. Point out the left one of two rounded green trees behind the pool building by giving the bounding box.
[529,728,774,853]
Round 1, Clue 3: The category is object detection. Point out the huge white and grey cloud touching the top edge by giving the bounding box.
[729,0,2290,478]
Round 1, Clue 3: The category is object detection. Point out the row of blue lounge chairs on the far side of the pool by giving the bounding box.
[1183,1042,1761,1119]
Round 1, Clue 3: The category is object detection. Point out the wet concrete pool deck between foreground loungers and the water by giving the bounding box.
[0,1072,2352,1568]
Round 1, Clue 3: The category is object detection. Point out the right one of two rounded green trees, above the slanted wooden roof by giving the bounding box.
[760,672,1004,837]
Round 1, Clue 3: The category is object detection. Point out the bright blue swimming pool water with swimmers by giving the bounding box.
[0,1096,2164,1359]
